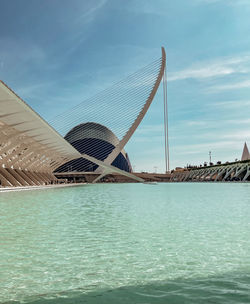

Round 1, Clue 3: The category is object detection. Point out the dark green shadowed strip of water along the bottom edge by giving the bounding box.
[21,273,250,304]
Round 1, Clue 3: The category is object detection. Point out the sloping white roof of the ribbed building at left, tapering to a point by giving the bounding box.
[0,81,143,181]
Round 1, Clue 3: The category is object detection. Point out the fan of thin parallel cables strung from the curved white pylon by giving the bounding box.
[49,58,162,171]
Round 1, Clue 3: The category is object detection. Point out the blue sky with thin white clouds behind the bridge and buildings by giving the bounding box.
[0,0,250,172]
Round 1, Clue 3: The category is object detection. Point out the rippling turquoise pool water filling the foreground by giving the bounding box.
[0,183,250,304]
